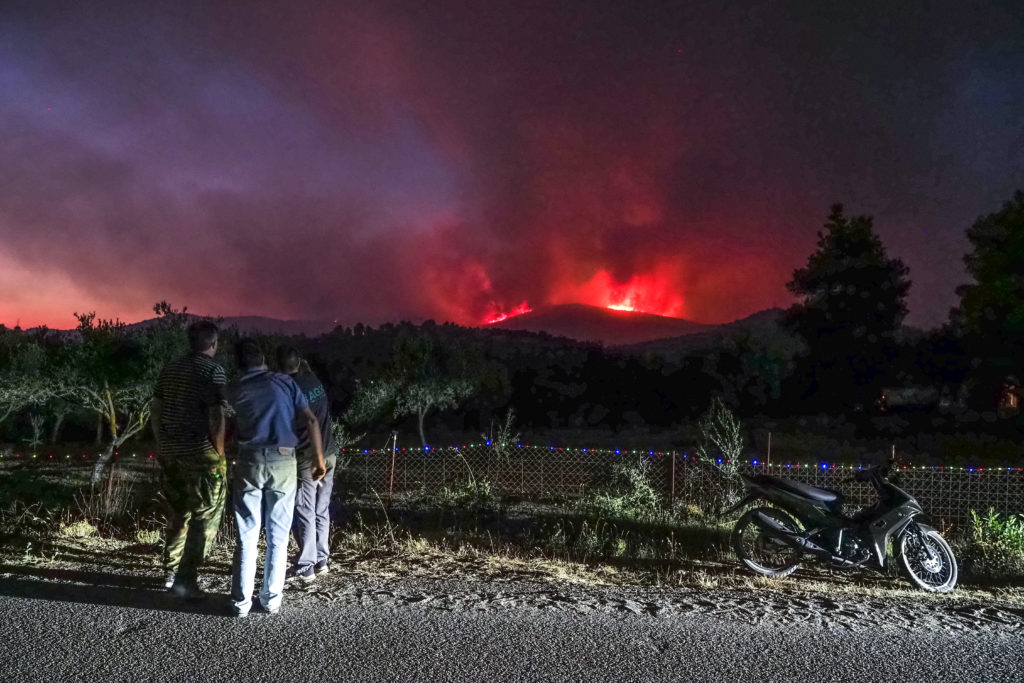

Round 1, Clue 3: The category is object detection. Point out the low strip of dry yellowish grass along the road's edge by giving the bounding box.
[0,520,1024,605]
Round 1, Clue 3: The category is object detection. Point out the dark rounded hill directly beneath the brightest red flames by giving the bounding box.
[483,303,719,346]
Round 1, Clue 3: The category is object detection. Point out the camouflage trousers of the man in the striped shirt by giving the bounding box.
[161,449,227,583]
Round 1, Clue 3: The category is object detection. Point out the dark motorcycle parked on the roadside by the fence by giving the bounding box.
[726,461,956,593]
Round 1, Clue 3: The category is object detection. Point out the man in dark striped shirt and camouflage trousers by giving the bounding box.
[151,321,227,598]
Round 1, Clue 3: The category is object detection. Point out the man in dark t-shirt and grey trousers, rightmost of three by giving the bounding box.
[276,346,338,582]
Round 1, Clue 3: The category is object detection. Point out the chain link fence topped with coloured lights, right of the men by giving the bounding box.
[339,445,1024,525]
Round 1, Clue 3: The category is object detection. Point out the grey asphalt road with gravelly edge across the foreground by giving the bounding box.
[0,575,1024,683]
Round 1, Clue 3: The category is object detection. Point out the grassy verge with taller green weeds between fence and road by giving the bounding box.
[0,464,1024,604]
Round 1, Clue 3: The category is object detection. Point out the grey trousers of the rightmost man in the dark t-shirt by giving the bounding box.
[292,453,338,571]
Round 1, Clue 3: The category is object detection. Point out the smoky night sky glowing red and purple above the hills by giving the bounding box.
[0,0,1024,328]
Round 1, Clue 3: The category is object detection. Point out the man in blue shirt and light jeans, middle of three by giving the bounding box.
[229,339,325,616]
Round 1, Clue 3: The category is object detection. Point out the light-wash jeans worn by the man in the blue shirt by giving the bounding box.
[231,449,296,613]
